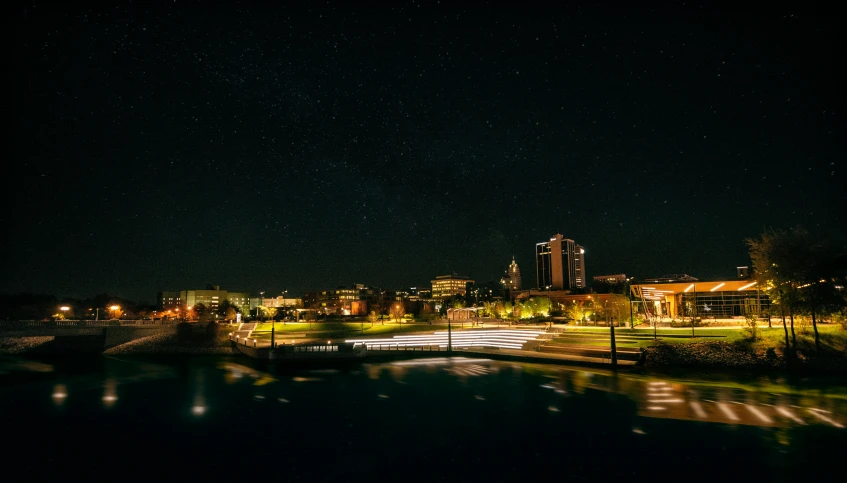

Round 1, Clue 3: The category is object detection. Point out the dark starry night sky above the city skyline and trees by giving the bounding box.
[6,0,847,302]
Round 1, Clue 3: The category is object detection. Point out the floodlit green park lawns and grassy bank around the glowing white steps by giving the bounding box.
[222,321,847,372]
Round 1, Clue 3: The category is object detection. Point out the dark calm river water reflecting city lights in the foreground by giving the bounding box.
[0,358,847,482]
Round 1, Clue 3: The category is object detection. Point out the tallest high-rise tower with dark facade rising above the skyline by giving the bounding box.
[535,234,585,290]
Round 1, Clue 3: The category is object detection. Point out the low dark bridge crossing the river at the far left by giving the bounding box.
[0,320,177,349]
